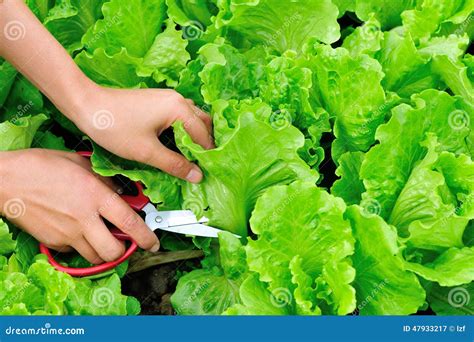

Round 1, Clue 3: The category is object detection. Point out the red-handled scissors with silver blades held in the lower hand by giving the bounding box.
[40,152,228,277]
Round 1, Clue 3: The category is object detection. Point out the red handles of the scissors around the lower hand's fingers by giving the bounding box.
[39,151,149,277]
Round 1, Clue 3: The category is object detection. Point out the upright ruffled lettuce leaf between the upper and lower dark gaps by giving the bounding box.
[314,46,389,161]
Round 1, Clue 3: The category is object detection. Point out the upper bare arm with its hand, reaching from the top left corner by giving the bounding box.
[0,1,214,183]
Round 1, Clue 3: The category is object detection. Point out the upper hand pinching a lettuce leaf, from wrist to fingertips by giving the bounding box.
[65,85,214,183]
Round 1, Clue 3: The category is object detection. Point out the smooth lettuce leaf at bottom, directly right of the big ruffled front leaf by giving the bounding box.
[346,206,425,315]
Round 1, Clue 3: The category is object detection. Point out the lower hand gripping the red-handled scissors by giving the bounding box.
[0,149,159,264]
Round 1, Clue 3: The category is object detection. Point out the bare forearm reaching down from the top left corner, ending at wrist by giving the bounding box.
[0,0,95,121]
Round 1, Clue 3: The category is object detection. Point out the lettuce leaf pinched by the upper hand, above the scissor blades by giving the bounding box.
[176,113,318,236]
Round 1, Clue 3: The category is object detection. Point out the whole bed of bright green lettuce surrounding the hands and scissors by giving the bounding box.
[0,0,474,315]
